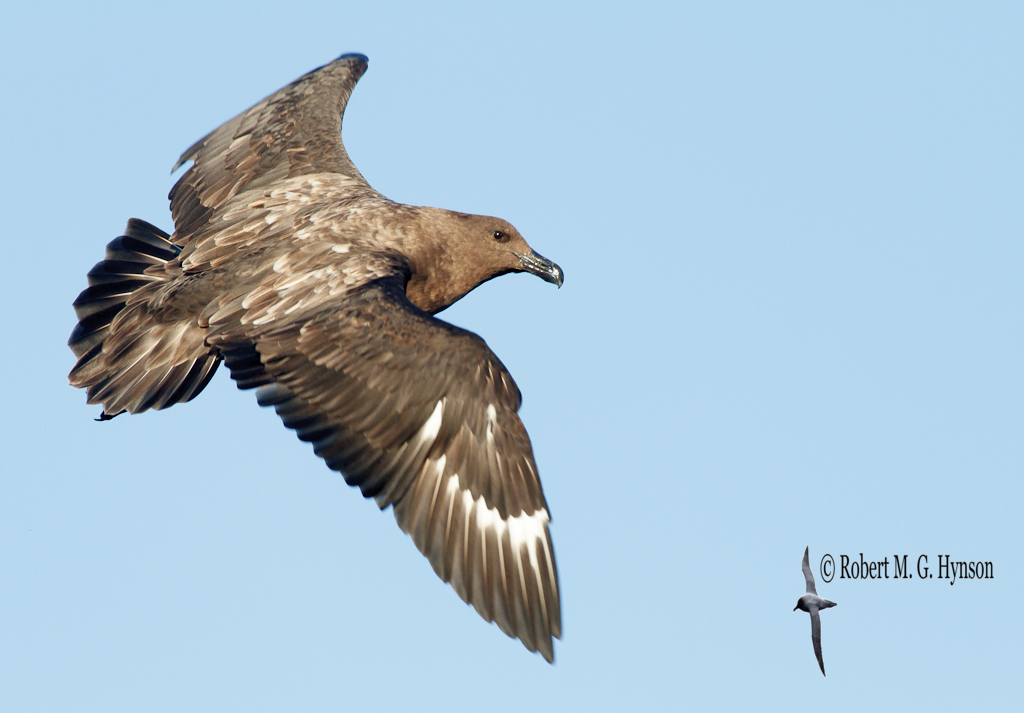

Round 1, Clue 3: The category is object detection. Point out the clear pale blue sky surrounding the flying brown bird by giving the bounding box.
[0,1,1024,713]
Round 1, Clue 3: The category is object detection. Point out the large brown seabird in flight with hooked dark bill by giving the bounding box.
[69,54,562,662]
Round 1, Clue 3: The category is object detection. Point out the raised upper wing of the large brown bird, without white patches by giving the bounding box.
[169,54,376,245]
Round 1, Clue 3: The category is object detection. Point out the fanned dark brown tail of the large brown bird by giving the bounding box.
[68,218,220,419]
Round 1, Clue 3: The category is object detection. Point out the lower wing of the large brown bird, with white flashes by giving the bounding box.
[210,276,561,661]
